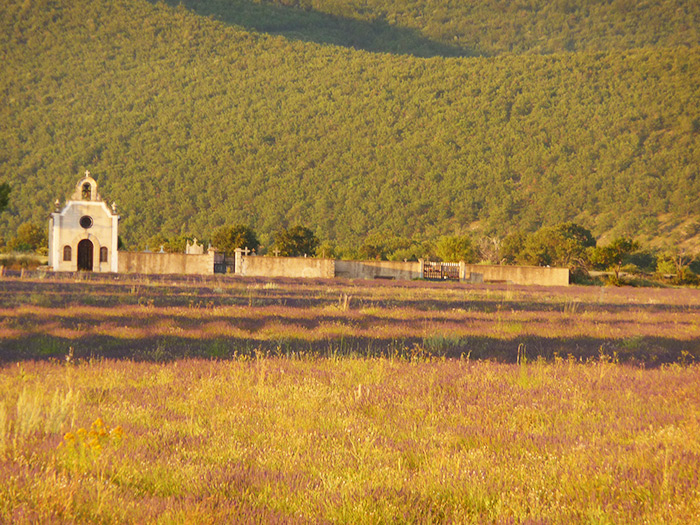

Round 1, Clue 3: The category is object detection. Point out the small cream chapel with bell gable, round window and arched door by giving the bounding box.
[49,171,119,273]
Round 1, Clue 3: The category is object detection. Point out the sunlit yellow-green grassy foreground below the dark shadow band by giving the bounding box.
[0,357,700,523]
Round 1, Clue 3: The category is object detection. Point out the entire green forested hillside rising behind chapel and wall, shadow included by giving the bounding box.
[0,0,700,251]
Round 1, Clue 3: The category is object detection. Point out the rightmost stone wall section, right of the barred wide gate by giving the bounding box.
[464,264,569,286]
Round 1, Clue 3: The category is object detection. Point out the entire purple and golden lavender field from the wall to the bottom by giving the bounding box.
[0,276,700,523]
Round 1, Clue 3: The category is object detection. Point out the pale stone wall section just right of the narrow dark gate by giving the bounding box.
[235,256,335,279]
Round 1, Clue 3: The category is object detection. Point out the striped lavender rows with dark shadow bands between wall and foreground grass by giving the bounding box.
[0,274,700,366]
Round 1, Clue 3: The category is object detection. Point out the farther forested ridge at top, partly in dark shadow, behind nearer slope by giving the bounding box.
[168,0,700,56]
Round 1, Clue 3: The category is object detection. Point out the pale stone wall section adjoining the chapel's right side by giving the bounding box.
[119,252,221,275]
